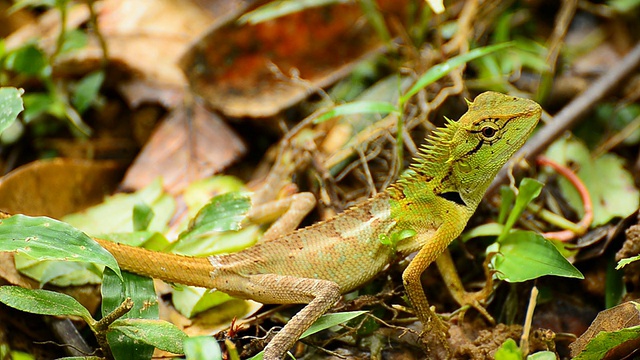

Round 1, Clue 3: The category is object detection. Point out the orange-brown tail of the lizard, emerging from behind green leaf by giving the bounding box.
[94,239,214,289]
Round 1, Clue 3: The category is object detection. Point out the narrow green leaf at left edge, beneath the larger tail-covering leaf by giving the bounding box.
[0,286,95,325]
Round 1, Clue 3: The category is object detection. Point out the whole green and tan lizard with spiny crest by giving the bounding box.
[91,92,542,360]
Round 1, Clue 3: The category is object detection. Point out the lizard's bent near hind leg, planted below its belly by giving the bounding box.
[238,274,341,360]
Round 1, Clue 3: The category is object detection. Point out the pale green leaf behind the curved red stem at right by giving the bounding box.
[547,139,640,227]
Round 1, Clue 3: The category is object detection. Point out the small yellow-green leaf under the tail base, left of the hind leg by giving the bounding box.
[172,285,233,318]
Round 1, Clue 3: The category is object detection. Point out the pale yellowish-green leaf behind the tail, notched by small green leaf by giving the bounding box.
[63,179,175,235]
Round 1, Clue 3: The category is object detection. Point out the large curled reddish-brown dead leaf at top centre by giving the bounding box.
[180,0,407,117]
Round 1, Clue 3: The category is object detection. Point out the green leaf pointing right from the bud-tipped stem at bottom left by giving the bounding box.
[109,319,187,354]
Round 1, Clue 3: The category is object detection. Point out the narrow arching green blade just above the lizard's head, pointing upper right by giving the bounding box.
[400,43,512,104]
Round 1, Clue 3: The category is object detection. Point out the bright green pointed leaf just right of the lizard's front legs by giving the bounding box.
[487,230,584,282]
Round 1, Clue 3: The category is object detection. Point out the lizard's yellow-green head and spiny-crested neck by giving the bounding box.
[412,92,542,209]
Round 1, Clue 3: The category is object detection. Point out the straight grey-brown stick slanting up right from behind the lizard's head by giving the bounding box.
[488,43,640,194]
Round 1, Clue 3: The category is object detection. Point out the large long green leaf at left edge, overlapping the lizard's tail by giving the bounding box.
[0,215,121,276]
